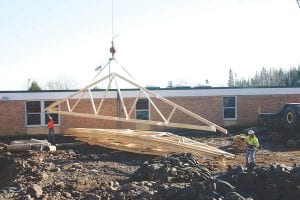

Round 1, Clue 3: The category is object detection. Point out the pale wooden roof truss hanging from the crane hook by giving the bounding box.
[45,72,227,133]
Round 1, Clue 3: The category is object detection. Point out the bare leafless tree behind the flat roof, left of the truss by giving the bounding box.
[46,76,78,90]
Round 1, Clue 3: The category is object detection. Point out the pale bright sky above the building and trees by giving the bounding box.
[0,0,300,90]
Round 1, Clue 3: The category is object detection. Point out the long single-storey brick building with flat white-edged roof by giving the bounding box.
[0,88,300,135]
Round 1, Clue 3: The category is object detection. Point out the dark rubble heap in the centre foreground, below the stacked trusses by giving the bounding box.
[127,153,245,199]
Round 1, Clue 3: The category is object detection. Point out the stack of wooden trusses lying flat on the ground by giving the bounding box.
[65,128,234,158]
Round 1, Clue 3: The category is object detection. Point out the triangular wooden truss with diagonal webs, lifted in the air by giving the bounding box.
[45,72,227,133]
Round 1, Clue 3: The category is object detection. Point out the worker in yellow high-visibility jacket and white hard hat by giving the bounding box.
[244,130,259,172]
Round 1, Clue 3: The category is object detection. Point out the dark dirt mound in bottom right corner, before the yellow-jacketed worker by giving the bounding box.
[219,164,300,200]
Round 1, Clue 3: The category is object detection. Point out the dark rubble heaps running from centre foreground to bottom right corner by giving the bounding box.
[132,154,300,200]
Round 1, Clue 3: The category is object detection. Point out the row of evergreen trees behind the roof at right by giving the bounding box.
[227,64,300,87]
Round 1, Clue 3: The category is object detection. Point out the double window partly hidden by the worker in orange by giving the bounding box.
[26,101,59,127]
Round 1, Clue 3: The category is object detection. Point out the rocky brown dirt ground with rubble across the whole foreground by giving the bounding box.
[0,131,300,200]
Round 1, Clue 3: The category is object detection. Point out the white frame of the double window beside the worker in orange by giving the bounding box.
[25,100,61,128]
